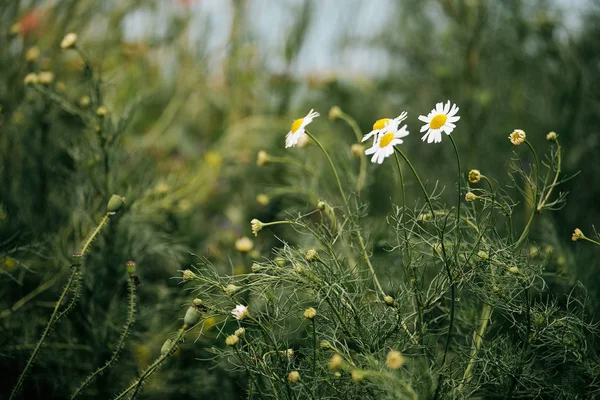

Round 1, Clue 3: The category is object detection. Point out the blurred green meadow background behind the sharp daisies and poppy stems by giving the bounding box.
[0,0,600,399]
